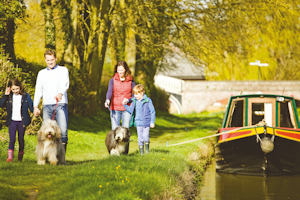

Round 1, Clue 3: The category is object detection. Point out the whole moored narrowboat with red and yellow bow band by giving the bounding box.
[215,94,300,175]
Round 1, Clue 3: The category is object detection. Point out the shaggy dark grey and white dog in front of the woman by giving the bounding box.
[105,127,130,156]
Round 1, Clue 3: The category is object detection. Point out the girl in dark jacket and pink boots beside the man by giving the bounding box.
[0,79,33,162]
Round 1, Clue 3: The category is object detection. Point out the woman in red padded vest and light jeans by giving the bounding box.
[104,61,135,130]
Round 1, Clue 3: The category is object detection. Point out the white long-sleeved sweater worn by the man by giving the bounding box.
[33,65,69,107]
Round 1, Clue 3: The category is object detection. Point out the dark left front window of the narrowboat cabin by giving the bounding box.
[228,100,244,127]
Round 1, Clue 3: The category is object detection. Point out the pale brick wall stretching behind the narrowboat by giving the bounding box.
[181,81,300,113]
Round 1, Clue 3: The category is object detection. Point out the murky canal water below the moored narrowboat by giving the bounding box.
[197,163,300,200]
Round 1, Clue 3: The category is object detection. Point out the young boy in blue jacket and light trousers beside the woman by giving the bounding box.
[123,84,155,155]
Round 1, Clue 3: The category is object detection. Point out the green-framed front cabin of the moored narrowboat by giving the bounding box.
[222,94,300,128]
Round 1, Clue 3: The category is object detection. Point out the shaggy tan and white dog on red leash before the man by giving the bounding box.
[36,119,65,165]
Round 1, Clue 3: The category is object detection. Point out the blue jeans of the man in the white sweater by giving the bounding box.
[43,104,68,143]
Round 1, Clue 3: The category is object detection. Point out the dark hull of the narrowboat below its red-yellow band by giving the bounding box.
[216,129,300,175]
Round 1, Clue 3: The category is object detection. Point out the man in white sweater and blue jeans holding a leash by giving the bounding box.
[33,50,69,153]
